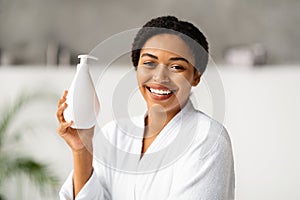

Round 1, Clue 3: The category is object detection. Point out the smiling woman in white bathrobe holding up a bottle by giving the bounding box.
[57,16,234,200]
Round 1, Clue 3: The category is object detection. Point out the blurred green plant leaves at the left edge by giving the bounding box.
[0,92,58,200]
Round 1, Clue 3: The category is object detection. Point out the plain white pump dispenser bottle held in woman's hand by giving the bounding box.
[64,55,100,129]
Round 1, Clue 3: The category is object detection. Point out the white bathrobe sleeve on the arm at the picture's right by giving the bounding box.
[168,128,235,200]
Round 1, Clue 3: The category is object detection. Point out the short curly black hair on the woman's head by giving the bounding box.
[131,16,208,74]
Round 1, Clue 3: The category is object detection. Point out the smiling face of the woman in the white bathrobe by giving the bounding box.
[137,34,200,113]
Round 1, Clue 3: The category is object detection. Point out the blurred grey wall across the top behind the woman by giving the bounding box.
[0,0,300,64]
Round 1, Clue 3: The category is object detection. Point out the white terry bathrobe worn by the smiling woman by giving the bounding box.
[60,101,235,200]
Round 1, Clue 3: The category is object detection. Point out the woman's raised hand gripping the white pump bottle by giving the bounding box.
[56,90,94,152]
